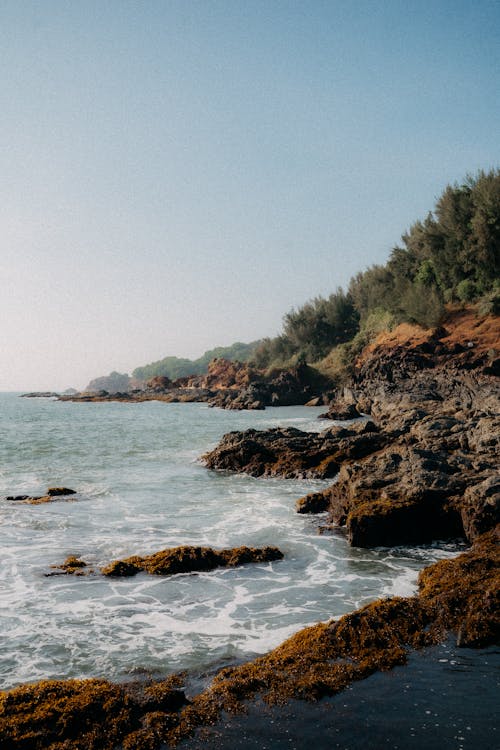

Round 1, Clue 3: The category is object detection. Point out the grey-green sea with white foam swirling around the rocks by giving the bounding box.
[0,394,457,689]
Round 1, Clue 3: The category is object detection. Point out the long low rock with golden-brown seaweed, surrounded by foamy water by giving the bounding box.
[101,546,283,577]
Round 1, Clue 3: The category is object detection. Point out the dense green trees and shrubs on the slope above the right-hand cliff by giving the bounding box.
[253,170,500,375]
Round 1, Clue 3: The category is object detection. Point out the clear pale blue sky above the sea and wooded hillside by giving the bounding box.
[0,0,500,391]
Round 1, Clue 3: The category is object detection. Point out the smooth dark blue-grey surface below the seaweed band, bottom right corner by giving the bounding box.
[179,642,500,750]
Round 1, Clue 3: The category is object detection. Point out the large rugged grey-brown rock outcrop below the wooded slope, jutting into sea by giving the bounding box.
[203,313,500,547]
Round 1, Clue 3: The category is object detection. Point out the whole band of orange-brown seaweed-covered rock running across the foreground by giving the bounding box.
[0,528,500,750]
